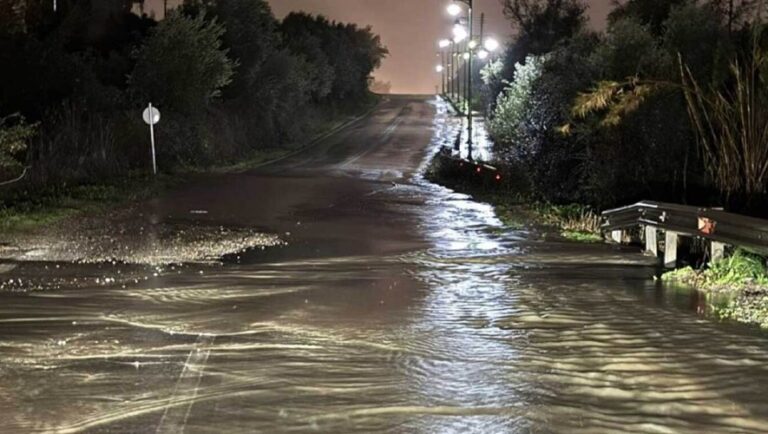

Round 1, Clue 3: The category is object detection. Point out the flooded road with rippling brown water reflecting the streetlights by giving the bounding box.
[0,97,768,433]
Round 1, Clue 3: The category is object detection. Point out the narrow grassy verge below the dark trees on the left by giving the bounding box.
[0,97,380,234]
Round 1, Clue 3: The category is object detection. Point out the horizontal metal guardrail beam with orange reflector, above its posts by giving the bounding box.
[602,201,768,253]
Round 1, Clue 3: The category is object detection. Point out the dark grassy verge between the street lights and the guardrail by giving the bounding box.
[425,150,603,243]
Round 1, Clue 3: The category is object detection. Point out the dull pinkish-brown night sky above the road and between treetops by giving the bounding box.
[142,0,611,93]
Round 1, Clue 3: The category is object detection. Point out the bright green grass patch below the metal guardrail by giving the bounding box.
[662,249,768,329]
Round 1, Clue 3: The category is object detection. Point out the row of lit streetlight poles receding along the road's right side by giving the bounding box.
[436,0,499,160]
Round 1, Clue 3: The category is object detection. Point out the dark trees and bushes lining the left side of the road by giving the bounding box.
[0,0,387,230]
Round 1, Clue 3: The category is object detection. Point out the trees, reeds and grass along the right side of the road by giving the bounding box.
[436,0,768,326]
